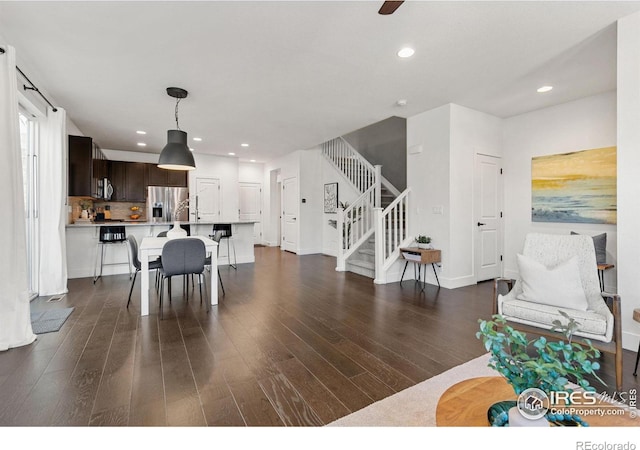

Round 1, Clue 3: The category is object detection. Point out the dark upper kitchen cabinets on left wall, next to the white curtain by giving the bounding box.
[69,135,108,197]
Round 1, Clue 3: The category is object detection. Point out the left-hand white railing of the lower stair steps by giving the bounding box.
[336,185,379,272]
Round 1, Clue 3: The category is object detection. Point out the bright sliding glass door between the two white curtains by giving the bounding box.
[20,112,38,299]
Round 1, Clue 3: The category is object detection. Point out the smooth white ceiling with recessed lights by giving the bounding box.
[0,1,640,161]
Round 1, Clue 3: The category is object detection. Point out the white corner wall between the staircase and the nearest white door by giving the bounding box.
[407,104,502,288]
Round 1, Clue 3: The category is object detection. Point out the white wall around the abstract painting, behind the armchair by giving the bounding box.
[503,92,616,292]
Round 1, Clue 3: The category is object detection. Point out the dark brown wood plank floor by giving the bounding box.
[0,247,639,426]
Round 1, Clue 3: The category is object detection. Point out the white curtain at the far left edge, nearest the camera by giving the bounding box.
[0,45,36,351]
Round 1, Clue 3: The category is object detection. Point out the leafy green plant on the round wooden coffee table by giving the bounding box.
[476,311,605,394]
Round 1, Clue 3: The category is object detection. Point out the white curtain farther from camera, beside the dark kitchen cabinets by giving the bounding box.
[38,108,67,295]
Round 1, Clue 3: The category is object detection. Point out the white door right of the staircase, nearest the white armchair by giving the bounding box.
[473,154,502,281]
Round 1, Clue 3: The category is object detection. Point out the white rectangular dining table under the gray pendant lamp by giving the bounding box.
[138,236,218,316]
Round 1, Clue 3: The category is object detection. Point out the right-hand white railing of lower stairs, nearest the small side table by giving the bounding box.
[374,188,413,284]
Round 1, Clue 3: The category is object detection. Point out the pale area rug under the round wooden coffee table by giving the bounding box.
[327,354,498,427]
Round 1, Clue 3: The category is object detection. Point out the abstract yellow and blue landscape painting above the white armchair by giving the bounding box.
[531,147,617,224]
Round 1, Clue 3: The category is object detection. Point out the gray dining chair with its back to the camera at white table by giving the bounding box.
[160,238,209,318]
